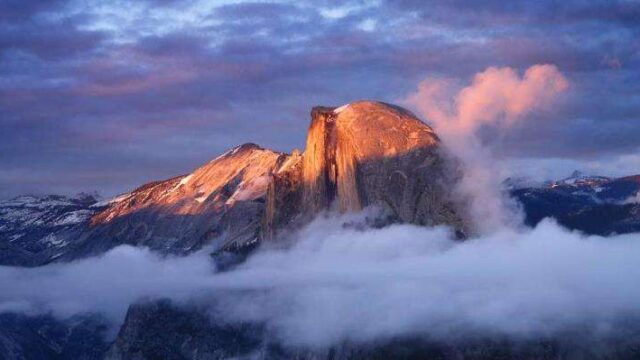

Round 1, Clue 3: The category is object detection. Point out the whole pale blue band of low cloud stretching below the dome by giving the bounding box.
[0,215,640,347]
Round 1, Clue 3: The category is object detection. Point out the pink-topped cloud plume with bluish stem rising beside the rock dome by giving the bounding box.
[405,65,569,233]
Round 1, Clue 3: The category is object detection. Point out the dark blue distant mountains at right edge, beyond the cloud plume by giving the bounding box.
[510,172,640,235]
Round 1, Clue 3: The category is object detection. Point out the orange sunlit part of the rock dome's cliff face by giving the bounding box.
[303,102,439,212]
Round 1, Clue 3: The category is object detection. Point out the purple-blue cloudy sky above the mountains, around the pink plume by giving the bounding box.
[0,0,640,197]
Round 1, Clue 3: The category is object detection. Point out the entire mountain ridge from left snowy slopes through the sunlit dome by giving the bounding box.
[0,101,465,266]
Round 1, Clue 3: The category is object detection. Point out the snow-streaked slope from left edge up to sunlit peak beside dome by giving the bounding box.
[0,144,288,266]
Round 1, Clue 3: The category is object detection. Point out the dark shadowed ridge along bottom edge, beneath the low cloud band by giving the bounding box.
[105,300,640,360]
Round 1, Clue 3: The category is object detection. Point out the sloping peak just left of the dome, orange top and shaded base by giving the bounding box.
[76,144,286,254]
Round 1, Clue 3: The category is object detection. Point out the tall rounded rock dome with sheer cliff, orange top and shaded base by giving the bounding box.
[264,101,464,238]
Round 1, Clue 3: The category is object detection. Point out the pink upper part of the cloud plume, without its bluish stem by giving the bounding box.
[407,65,569,134]
